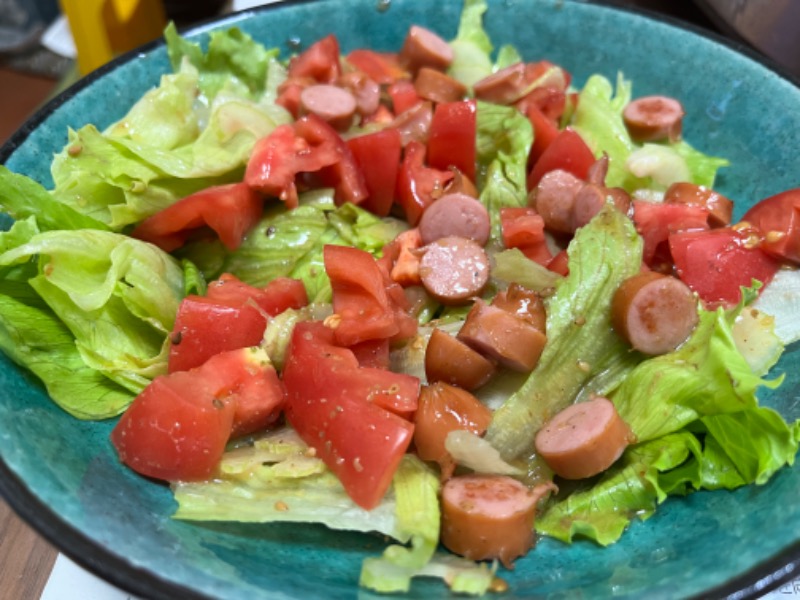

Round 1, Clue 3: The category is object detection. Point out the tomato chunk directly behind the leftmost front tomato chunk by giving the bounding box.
[169,275,308,373]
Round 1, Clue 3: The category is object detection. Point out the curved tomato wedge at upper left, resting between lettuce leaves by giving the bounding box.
[131,183,264,252]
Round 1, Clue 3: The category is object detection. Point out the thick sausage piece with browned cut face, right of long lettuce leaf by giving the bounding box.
[611,271,698,355]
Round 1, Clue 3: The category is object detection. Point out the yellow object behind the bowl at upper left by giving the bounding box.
[60,0,166,75]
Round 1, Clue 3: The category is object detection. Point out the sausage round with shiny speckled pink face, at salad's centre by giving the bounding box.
[419,236,490,304]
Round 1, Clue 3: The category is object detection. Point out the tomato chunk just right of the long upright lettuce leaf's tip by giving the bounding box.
[633,200,709,267]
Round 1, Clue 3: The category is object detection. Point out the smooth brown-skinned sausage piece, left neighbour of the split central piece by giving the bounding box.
[425,329,495,391]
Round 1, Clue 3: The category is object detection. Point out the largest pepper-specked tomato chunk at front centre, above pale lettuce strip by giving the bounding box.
[283,322,416,510]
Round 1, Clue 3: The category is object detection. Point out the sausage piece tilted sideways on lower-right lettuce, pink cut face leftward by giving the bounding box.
[534,396,635,479]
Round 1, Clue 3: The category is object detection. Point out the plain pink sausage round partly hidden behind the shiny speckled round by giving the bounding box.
[419,194,491,246]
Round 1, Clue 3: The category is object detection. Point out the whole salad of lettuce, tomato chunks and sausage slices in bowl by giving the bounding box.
[0,0,800,594]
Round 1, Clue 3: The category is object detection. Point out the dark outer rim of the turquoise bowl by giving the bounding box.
[0,0,800,600]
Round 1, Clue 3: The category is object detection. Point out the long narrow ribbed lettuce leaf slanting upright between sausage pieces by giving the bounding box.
[486,205,642,460]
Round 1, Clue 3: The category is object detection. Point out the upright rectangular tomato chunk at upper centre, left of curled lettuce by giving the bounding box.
[428,100,477,181]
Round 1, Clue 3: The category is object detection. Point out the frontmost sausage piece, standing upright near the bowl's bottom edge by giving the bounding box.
[441,475,558,568]
